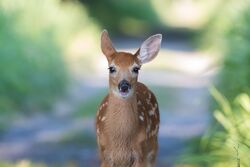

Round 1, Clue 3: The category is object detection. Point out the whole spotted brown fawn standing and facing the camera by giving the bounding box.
[96,30,162,167]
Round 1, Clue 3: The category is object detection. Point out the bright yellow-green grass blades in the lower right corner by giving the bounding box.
[182,89,250,167]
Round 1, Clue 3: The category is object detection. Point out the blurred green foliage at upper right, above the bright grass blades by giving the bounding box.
[204,0,250,102]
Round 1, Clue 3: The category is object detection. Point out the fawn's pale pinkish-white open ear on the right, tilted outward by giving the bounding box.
[136,34,162,64]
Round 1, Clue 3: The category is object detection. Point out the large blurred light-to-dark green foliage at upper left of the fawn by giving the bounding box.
[0,0,97,112]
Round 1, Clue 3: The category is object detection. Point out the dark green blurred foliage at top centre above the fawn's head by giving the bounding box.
[79,0,162,36]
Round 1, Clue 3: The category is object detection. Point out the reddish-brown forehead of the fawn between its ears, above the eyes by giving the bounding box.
[112,52,139,69]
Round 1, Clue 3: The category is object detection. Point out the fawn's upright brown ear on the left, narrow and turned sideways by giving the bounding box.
[101,30,116,62]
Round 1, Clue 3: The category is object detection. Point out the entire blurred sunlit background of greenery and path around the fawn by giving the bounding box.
[0,0,250,167]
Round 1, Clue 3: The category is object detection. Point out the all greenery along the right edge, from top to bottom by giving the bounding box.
[176,0,250,167]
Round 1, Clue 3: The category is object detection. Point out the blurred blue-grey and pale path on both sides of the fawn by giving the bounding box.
[0,39,216,167]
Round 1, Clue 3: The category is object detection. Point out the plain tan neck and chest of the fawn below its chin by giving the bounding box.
[105,90,139,143]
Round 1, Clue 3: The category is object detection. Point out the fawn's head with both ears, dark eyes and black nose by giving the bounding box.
[101,30,162,99]
